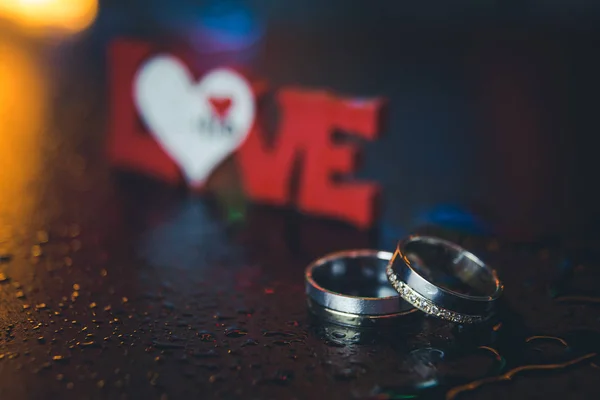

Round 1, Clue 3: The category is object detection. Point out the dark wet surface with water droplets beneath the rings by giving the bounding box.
[0,167,600,399]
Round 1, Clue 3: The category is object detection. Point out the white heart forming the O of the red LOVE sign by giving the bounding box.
[133,55,255,186]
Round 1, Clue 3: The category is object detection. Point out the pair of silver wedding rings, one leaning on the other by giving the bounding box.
[305,236,503,326]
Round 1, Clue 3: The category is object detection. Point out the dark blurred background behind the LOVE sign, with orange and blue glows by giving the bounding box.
[0,0,600,247]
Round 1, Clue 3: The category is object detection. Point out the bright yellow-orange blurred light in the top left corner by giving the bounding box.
[0,0,98,33]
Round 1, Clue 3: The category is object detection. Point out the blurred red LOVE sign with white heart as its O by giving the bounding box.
[108,40,384,228]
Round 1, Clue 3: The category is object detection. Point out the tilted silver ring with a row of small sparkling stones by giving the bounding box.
[386,236,503,323]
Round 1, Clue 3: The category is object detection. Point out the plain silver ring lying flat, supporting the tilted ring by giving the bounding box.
[305,250,414,326]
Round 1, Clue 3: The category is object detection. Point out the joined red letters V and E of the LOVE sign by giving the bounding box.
[239,89,383,228]
